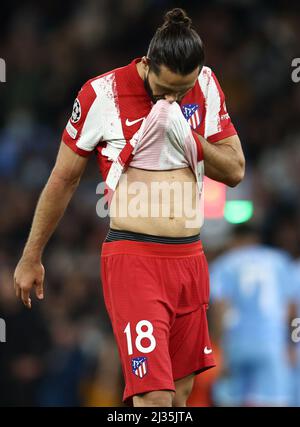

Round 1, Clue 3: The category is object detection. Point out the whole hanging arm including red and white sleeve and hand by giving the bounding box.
[14,80,103,308]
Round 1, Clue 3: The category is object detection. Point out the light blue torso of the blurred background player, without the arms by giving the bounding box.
[223,249,288,348]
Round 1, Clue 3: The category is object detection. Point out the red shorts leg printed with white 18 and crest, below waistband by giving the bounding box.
[102,249,175,401]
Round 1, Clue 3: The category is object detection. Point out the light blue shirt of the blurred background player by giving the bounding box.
[210,245,295,357]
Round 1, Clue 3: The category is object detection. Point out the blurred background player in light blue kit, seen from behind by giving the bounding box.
[210,224,295,406]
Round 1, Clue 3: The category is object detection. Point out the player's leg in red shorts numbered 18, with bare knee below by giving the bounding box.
[102,240,178,407]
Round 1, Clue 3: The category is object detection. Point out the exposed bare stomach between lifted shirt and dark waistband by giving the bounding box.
[110,167,202,237]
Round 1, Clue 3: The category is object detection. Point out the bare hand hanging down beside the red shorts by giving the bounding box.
[14,258,45,308]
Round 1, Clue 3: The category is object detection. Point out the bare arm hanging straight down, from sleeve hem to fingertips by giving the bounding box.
[14,142,88,308]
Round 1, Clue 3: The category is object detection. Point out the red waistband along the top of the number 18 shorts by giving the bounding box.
[101,240,203,258]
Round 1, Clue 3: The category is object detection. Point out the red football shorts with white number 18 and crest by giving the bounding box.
[101,240,215,404]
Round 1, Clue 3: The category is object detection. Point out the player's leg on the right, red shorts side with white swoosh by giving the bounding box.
[169,245,215,406]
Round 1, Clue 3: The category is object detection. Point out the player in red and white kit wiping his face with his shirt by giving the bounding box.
[15,9,244,406]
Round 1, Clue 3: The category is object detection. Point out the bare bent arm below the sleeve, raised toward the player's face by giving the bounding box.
[198,135,245,187]
